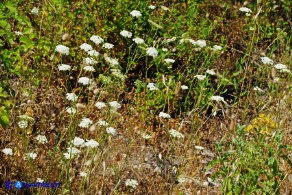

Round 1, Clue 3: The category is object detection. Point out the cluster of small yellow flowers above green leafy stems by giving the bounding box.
[245,114,276,134]
